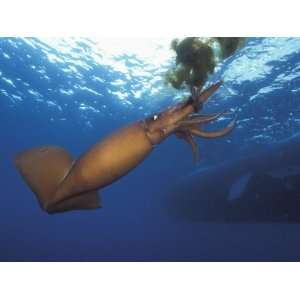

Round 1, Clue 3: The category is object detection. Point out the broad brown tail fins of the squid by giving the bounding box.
[15,146,101,213]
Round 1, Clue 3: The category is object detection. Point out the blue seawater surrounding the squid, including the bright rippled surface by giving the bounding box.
[0,38,300,261]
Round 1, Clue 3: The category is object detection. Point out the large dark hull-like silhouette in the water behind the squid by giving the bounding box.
[168,135,300,223]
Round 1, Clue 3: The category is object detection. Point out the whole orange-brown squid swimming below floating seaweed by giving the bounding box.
[15,82,235,214]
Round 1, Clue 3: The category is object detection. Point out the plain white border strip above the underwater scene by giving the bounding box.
[0,0,300,38]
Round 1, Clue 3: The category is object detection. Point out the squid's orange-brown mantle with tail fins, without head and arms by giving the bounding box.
[15,123,152,213]
